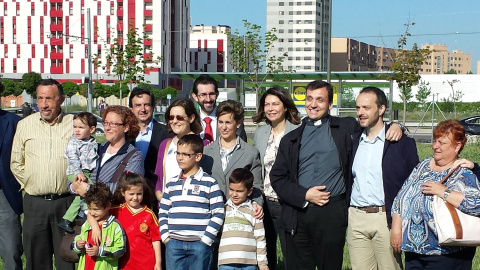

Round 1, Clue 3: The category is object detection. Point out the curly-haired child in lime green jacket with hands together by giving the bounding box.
[73,183,127,270]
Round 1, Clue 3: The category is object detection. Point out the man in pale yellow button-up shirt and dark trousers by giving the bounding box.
[10,79,75,270]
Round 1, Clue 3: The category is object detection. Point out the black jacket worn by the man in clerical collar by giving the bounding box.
[270,116,360,234]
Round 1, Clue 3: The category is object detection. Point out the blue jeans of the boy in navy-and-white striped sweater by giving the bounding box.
[165,238,213,270]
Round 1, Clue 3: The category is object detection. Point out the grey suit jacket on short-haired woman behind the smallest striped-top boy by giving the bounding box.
[200,140,263,206]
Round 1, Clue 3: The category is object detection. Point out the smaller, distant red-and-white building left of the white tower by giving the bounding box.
[189,25,233,72]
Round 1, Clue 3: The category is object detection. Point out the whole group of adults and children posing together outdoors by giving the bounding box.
[0,75,480,269]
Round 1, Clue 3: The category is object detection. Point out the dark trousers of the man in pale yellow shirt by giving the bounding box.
[23,194,75,270]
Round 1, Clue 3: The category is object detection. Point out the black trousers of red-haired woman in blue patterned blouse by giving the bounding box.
[405,247,477,270]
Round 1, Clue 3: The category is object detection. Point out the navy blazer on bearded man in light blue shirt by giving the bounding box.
[347,125,419,227]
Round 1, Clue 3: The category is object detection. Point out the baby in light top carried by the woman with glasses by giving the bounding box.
[58,112,98,233]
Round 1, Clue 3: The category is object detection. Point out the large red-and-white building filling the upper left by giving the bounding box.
[0,0,190,84]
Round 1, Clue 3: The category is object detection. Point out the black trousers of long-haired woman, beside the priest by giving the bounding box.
[263,198,286,270]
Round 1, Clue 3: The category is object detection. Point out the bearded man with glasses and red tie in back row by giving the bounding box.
[192,75,247,142]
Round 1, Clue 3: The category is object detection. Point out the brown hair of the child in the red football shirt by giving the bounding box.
[113,171,153,209]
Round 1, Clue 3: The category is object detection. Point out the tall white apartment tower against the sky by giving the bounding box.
[267,0,330,72]
